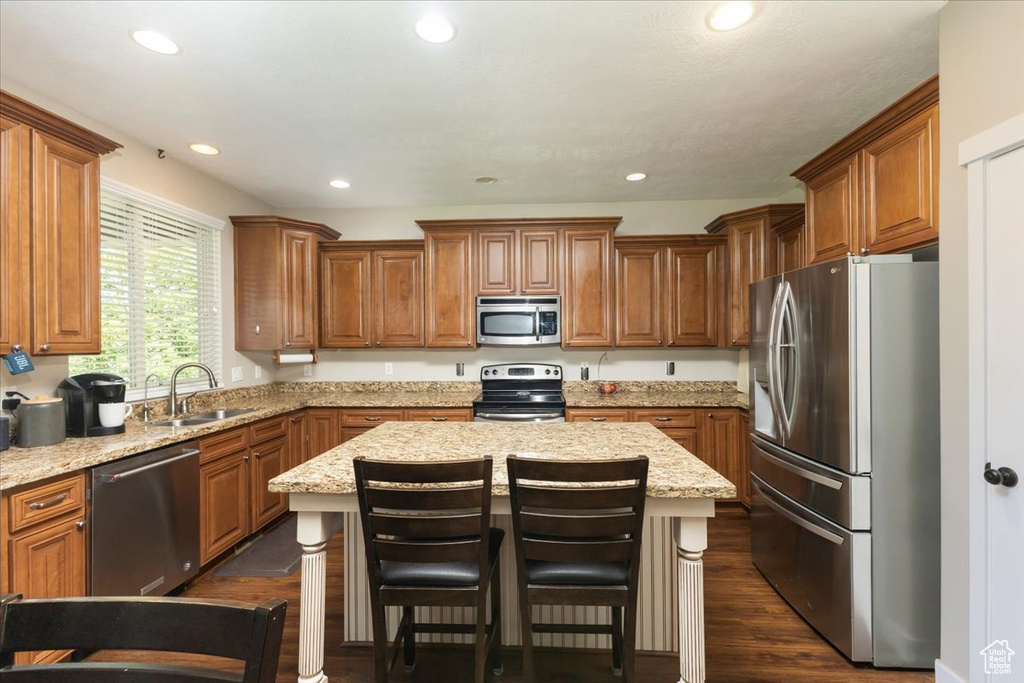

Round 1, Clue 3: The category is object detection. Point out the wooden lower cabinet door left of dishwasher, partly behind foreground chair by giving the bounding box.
[9,516,86,664]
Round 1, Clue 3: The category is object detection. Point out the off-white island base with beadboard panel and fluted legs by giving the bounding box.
[291,493,715,683]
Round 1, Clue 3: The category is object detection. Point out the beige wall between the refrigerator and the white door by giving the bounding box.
[939,0,1024,681]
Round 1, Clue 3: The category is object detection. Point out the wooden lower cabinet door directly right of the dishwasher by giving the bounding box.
[199,450,249,564]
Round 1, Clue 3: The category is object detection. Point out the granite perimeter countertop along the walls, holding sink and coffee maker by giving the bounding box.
[0,382,746,490]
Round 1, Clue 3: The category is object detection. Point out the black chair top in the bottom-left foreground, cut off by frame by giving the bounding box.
[0,595,287,683]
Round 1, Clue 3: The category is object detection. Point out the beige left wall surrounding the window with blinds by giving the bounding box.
[0,77,273,395]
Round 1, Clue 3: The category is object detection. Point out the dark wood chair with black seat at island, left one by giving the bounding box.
[352,458,504,683]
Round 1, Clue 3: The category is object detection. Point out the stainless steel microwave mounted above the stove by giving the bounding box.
[476,296,562,346]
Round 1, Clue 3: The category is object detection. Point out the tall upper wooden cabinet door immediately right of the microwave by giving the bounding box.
[562,228,615,348]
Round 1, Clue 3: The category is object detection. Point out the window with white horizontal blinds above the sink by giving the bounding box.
[70,178,223,400]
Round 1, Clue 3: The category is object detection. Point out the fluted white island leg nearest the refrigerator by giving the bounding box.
[672,517,708,683]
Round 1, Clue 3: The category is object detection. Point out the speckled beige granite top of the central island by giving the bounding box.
[269,422,736,498]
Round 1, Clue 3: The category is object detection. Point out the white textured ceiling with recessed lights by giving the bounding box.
[0,0,943,208]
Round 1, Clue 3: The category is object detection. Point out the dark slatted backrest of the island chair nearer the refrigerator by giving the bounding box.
[507,456,647,574]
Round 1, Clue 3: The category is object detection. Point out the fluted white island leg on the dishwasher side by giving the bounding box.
[296,512,333,683]
